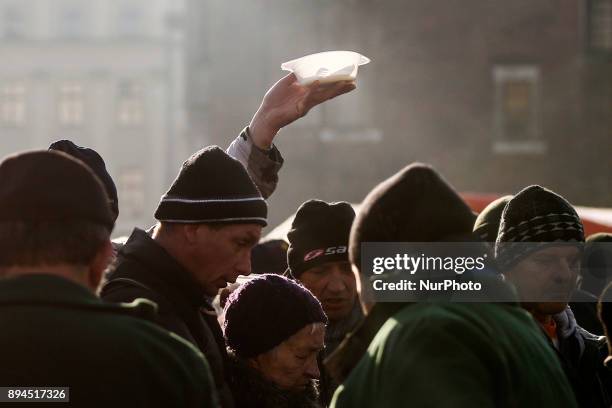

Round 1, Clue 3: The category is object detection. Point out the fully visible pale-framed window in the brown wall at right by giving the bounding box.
[493,65,545,153]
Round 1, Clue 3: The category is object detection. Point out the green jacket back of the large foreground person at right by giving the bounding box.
[331,303,576,408]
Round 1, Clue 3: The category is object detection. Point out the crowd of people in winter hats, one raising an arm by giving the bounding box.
[0,74,612,408]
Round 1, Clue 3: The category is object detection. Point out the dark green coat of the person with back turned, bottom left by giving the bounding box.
[0,275,217,408]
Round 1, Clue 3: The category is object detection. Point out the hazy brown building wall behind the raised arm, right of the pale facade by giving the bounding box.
[185,0,612,230]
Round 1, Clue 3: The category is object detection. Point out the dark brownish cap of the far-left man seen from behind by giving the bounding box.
[0,150,115,231]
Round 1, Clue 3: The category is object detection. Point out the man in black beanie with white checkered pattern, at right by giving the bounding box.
[495,185,612,408]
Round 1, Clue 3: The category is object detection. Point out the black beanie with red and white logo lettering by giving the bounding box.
[287,200,355,278]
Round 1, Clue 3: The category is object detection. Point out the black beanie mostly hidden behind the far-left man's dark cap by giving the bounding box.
[49,140,119,221]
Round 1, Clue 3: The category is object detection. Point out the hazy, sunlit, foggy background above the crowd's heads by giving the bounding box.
[0,0,612,235]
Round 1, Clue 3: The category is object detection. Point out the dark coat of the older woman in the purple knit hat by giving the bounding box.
[228,356,322,408]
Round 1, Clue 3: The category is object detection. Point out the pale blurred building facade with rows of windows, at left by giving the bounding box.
[0,0,186,235]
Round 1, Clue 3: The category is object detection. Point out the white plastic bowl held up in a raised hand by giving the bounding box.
[281,51,370,85]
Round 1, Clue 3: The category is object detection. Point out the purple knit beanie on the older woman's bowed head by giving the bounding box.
[223,274,327,359]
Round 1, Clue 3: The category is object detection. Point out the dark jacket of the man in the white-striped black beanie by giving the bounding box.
[100,229,233,408]
